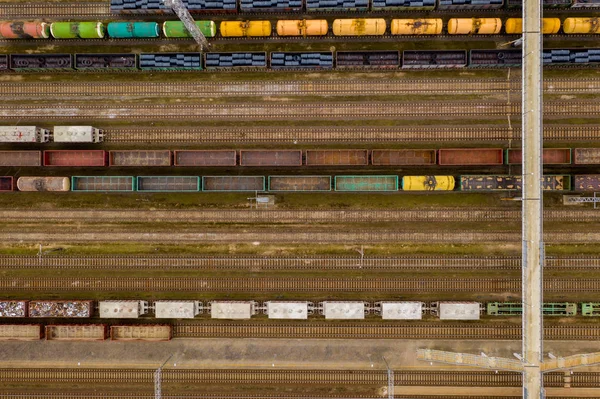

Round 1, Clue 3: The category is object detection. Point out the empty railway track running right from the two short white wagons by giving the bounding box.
[104,125,600,144]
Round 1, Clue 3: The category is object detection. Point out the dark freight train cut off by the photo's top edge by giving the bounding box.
[111,0,600,14]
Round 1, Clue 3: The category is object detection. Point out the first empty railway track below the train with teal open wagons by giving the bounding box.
[0,208,600,224]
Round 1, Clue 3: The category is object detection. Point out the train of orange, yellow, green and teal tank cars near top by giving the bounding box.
[0,17,600,39]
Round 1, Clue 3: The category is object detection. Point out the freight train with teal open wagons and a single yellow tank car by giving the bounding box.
[0,175,600,194]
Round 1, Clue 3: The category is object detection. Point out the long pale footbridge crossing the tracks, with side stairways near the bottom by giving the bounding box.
[417,0,600,399]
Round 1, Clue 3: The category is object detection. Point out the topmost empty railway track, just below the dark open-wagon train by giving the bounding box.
[0,79,600,99]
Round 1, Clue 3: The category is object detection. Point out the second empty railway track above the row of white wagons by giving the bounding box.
[0,255,600,271]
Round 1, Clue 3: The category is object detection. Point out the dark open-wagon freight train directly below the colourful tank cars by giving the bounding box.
[0,48,600,73]
